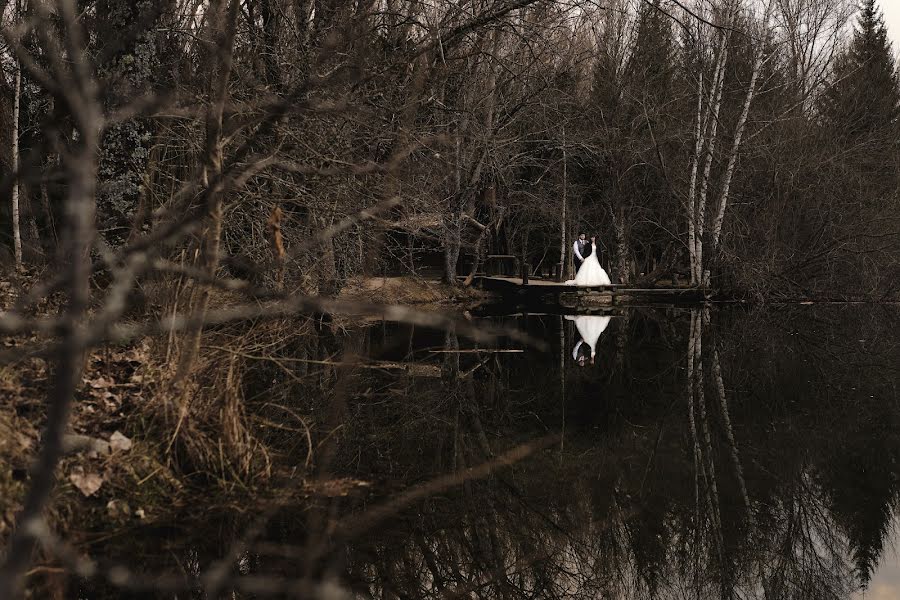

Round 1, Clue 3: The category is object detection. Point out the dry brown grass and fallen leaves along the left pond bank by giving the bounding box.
[0,268,492,584]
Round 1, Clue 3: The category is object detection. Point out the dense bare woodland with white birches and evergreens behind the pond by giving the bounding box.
[0,0,900,298]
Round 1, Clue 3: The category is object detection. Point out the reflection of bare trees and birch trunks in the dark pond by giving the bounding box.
[334,309,900,598]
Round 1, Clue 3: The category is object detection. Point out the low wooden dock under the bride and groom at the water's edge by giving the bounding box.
[475,276,712,310]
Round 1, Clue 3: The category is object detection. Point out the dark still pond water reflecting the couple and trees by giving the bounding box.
[82,305,900,599]
